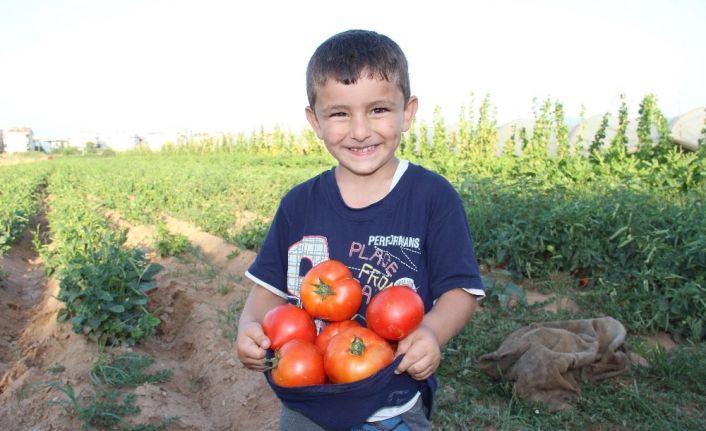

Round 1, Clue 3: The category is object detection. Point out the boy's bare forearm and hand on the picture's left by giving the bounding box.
[237,285,287,371]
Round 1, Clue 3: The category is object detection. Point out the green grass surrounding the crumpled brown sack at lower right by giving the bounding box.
[433,297,706,431]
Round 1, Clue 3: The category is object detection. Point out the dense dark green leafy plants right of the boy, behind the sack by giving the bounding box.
[459,150,706,339]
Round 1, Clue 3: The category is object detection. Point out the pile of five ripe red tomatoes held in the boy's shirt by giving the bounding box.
[262,260,424,387]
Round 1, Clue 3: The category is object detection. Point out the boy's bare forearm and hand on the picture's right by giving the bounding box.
[395,289,476,380]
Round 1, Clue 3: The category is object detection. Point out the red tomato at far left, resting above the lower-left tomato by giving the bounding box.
[262,304,316,350]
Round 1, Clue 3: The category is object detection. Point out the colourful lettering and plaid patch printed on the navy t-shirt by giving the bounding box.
[287,235,421,304]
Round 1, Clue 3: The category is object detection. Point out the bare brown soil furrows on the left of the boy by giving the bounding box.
[0,213,280,431]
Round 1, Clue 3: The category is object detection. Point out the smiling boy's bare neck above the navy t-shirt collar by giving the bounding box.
[335,157,400,208]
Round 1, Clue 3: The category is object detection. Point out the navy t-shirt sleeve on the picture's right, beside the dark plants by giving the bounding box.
[427,184,485,299]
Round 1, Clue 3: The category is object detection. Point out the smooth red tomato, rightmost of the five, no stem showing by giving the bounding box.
[365,286,424,340]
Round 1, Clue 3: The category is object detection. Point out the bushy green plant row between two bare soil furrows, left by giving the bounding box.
[40,169,161,345]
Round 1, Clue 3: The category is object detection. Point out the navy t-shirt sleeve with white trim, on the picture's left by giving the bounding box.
[245,200,290,299]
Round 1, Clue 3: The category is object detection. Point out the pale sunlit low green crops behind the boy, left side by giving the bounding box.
[48,153,333,249]
